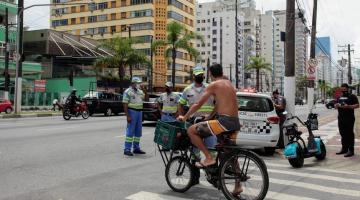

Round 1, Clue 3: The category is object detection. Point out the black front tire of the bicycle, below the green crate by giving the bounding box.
[165,156,194,193]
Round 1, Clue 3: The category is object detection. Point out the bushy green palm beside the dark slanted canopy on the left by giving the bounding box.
[95,37,149,91]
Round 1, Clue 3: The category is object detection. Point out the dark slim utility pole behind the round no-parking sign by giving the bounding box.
[307,0,317,111]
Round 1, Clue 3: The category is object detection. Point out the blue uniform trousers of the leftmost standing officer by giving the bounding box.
[124,109,142,151]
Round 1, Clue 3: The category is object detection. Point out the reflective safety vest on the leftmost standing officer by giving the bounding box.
[122,87,145,110]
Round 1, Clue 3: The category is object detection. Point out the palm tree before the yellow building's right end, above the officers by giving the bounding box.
[152,21,203,87]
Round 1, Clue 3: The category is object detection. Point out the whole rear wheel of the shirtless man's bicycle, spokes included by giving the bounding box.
[219,150,269,200]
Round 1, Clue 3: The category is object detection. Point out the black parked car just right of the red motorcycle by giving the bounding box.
[83,91,124,116]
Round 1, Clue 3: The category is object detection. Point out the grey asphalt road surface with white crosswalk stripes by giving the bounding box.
[0,107,360,200]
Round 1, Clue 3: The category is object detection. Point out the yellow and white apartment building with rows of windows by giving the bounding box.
[51,0,195,87]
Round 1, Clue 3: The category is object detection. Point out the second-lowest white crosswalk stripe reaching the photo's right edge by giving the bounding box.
[268,169,360,184]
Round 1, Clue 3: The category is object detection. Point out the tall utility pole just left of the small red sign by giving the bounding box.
[14,0,24,114]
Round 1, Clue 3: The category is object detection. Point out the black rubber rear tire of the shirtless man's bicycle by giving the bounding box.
[219,149,269,200]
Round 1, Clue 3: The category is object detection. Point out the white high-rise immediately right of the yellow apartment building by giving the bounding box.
[196,1,244,87]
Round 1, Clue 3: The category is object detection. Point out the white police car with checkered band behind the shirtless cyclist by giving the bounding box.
[236,91,280,155]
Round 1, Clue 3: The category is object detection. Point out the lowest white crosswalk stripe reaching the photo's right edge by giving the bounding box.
[252,176,360,197]
